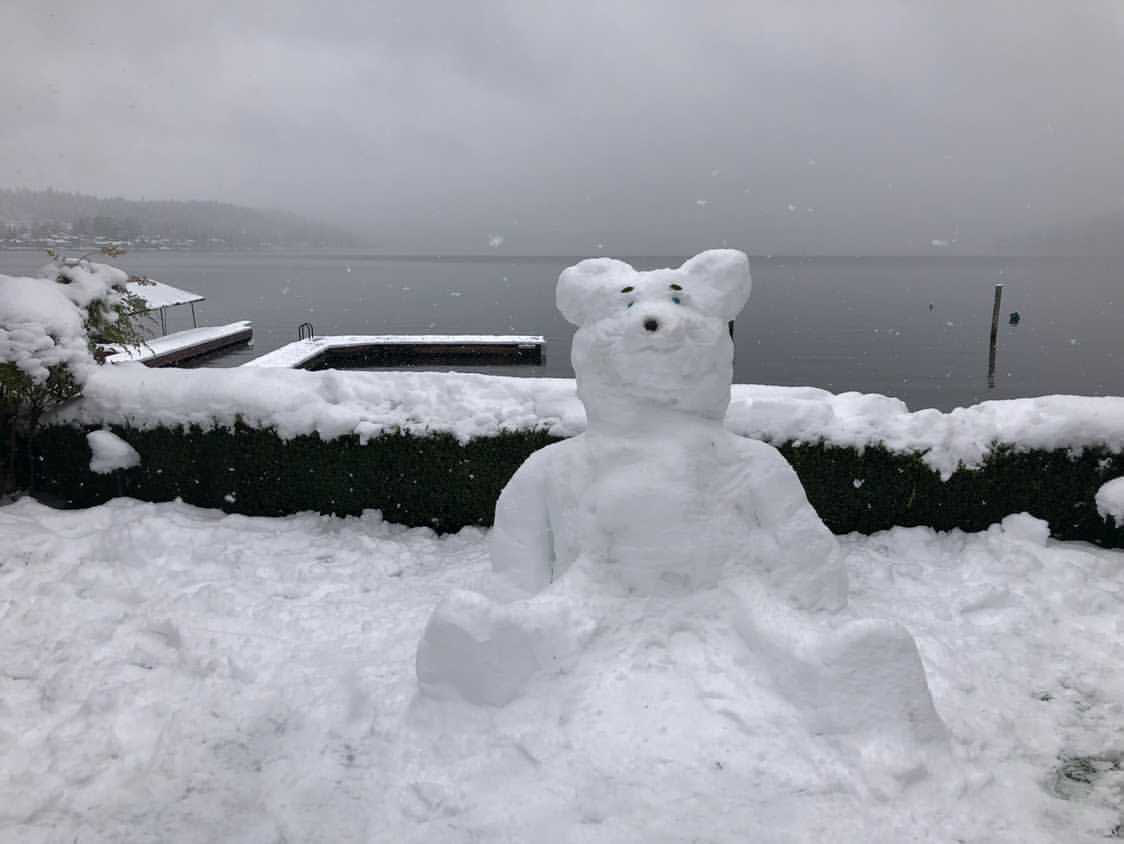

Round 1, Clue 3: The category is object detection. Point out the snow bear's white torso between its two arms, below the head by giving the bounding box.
[544,424,771,595]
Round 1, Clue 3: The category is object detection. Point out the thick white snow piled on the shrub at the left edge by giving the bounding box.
[0,261,128,383]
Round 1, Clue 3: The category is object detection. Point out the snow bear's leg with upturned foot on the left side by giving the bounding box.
[417,590,592,706]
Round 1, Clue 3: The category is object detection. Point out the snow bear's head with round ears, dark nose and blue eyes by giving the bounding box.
[558,249,751,424]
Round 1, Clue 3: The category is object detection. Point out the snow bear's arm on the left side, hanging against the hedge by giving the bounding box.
[488,446,555,593]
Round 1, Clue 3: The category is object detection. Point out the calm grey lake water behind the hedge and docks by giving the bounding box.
[0,252,1124,410]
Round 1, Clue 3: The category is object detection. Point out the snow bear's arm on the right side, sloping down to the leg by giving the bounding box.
[740,439,847,610]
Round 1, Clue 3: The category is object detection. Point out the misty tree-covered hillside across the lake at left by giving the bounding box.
[0,189,357,248]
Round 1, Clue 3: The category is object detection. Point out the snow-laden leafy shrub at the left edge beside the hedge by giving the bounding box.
[0,248,145,491]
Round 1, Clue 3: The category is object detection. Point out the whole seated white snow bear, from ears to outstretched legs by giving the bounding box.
[417,249,943,764]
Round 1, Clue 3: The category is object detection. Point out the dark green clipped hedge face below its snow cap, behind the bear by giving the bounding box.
[27,424,1124,547]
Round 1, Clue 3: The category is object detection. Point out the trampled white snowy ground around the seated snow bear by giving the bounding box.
[0,499,1124,843]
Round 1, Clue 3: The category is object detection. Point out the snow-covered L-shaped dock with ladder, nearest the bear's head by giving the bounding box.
[243,334,545,369]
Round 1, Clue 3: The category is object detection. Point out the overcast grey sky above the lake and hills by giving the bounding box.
[0,0,1124,254]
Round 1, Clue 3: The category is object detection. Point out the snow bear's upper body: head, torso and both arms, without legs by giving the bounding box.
[491,249,846,609]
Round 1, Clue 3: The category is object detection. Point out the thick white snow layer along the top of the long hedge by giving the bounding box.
[55,364,1124,478]
